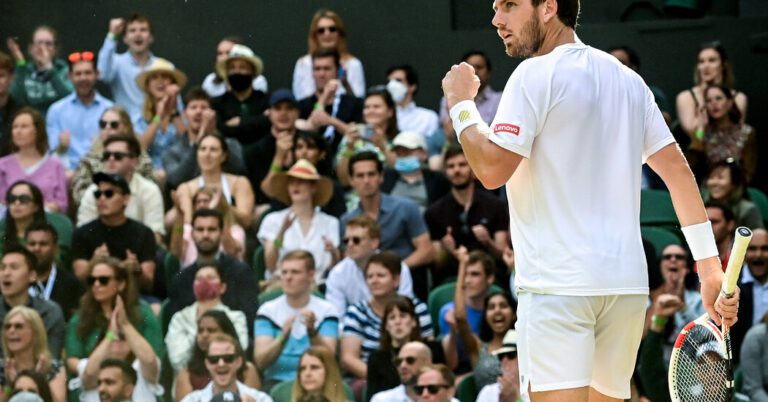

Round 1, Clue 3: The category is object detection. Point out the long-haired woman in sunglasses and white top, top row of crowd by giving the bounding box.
[293,9,365,99]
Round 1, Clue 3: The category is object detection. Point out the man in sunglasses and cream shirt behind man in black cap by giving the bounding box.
[77,134,165,244]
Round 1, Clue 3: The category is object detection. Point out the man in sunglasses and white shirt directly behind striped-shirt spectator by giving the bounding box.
[325,215,413,317]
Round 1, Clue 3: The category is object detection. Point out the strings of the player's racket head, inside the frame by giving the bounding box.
[673,325,731,402]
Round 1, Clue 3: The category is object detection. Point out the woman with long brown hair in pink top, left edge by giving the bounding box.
[0,107,68,213]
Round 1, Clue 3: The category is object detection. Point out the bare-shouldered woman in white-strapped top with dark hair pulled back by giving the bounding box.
[176,134,254,228]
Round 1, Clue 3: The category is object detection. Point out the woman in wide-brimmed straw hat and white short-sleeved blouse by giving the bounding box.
[258,159,340,283]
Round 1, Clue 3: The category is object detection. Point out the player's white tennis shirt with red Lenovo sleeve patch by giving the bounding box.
[489,38,674,296]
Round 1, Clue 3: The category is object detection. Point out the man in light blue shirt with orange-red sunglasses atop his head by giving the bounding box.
[45,51,113,171]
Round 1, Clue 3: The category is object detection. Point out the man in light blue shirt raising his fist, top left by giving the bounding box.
[99,14,156,120]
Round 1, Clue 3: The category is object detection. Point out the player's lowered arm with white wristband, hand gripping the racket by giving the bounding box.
[648,143,738,325]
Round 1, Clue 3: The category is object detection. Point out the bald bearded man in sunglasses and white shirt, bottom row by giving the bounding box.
[371,342,432,402]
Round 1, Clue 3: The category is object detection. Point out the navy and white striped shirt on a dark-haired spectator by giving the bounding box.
[344,297,435,362]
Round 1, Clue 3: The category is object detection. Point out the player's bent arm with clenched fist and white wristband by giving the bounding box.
[443,63,523,189]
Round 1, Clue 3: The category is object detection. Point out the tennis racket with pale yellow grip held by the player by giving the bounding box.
[668,226,752,402]
